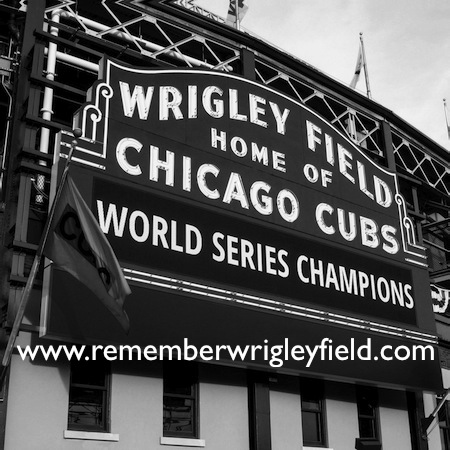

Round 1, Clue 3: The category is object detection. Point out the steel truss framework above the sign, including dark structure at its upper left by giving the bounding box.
[6,0,450,256]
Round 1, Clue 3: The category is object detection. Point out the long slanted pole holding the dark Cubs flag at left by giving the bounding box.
[0,128,82,386]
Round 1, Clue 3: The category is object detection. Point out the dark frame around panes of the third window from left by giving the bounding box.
[300,378,328,448]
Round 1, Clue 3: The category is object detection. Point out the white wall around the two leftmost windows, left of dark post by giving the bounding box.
[5,340,249,450]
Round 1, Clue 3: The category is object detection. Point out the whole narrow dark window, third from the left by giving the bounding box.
[300,380,326,447]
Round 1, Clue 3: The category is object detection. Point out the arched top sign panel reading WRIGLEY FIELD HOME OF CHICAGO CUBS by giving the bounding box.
[72,61,425,264]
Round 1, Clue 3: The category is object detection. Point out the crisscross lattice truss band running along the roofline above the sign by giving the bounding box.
[37,0,449,183]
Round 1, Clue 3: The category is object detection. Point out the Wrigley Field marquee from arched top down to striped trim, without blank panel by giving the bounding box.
[44,60,431,348]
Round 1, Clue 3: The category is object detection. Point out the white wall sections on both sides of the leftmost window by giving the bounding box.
[5,338,165,450]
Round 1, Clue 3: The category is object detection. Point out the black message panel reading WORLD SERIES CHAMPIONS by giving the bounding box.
[93,179,415,324]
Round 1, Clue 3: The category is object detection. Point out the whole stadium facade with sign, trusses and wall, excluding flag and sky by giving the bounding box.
[0,0,450,450]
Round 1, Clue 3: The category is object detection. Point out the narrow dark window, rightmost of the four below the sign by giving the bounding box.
[357,387,380,441]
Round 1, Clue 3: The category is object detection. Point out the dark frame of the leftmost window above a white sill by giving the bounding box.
[67,360,111,433]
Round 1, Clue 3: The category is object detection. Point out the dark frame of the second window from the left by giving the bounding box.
[163,360,200,439]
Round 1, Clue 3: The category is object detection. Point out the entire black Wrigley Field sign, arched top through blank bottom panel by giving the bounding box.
[43,60,439,388]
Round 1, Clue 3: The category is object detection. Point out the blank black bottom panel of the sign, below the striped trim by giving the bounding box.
[44,270,442,391]
